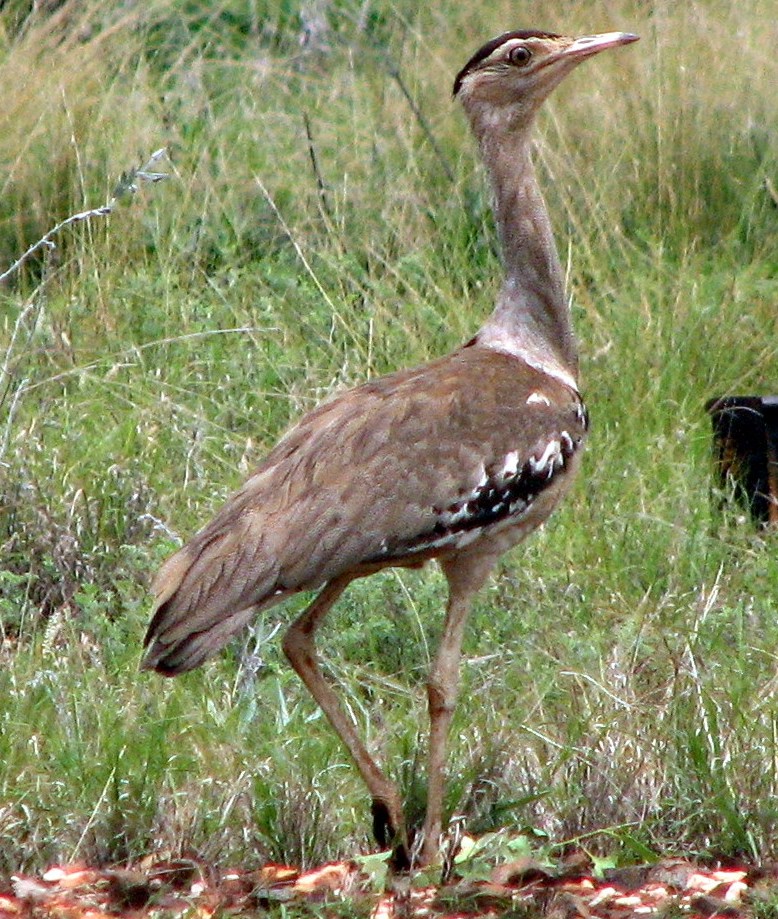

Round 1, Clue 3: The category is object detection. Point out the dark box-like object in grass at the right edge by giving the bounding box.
[705,396,778,526]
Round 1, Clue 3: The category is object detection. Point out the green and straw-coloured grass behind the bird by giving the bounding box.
[0,0,778,873]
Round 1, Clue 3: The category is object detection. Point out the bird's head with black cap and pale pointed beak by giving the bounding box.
[454,30,638,128]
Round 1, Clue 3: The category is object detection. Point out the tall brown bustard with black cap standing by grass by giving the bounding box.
[141,29,638,869]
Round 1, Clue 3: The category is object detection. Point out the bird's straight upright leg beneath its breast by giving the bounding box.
[420,556,493,867]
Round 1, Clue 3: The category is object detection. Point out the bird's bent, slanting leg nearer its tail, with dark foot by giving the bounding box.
[283,575,408,867]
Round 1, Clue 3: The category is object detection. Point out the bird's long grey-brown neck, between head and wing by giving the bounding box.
[466,119,578,386]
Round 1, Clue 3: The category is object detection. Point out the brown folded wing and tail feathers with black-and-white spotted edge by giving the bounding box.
[144,348,583,674]
